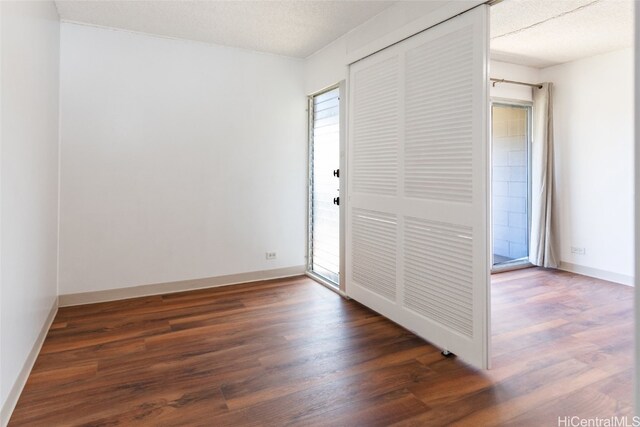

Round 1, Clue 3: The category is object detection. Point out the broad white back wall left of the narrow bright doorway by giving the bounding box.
[59,23,307,295]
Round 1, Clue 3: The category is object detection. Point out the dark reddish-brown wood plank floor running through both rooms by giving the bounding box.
[10,269,633,426]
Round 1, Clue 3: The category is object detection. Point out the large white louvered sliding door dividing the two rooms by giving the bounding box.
[346,5,490,368]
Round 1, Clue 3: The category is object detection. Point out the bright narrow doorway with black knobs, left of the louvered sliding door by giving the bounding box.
[307,86,340,288]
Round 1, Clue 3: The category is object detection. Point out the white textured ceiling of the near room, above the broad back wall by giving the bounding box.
[56,0,395,58]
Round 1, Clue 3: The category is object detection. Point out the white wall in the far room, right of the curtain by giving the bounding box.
[541,48,634,284]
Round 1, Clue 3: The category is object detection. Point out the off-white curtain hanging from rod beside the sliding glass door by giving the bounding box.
[529,83,558,268]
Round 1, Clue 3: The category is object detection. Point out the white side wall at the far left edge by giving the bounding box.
[0,2,60,423]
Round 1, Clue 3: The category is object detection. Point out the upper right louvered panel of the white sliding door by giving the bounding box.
[404,27,474,203]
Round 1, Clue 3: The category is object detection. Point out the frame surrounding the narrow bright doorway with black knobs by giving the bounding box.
[305,80,348,298]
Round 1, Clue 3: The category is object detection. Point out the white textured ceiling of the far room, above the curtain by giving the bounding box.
[491,0,633,68]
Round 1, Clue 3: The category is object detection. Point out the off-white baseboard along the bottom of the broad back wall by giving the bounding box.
[58,265,306,307]
